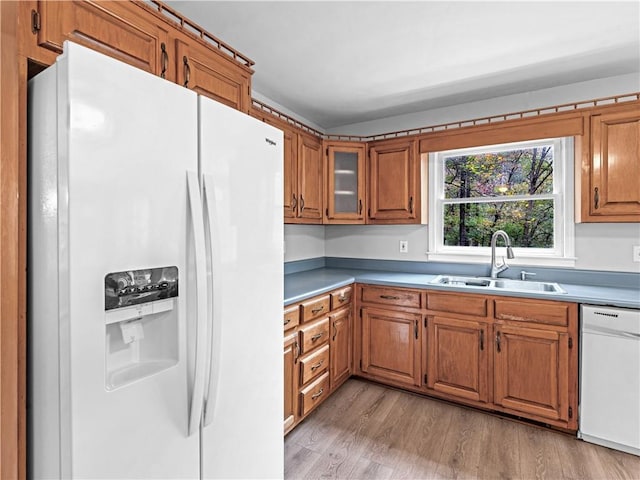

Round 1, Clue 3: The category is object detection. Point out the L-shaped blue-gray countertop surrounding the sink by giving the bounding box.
[284,268,640,308]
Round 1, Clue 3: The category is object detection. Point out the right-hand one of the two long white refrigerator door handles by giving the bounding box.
[203,174,222,427]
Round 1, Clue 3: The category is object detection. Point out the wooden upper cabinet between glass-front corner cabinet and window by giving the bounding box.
[367,140,421,224]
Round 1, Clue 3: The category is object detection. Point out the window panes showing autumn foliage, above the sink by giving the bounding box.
[443,144,554,248]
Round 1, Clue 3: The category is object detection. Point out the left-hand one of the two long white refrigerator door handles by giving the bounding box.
[187,172,207,436]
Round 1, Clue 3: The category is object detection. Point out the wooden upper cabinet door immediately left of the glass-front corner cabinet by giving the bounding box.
[294,134,322,223]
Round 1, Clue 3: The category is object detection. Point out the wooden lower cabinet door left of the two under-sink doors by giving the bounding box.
[361,307,422,386]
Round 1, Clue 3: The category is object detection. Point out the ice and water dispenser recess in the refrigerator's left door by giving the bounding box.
[104,267,179,390]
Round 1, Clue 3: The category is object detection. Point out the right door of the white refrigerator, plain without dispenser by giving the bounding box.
[199,97,284,478]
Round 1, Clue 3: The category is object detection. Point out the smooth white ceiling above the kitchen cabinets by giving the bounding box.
[166,0,640,129]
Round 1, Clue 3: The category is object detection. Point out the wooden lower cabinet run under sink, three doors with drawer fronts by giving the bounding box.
[354,285,578,432]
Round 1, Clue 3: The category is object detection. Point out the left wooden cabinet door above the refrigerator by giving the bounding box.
[32,1,169,75]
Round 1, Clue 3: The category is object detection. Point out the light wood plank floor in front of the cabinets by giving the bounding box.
[285,379,640,480]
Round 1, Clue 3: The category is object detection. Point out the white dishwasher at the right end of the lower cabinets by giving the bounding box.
[578,305,640,455]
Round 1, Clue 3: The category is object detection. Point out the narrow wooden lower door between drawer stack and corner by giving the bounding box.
[329,307,353,390]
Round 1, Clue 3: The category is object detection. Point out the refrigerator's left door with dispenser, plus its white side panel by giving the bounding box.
[30,42,202,479]
